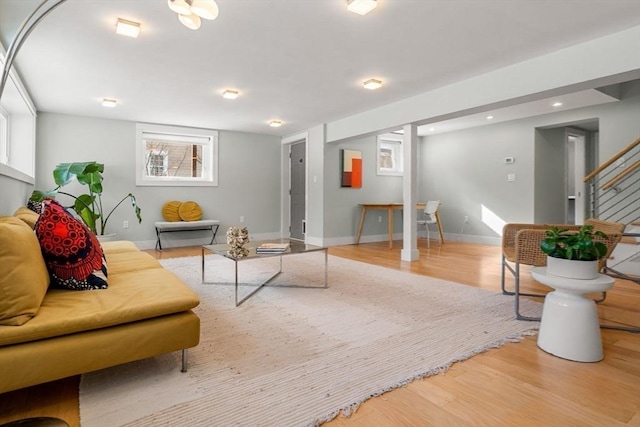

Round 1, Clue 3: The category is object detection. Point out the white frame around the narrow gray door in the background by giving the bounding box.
[280,132,309,243]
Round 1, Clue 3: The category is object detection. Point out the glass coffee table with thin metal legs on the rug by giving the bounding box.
[202,240,328,307]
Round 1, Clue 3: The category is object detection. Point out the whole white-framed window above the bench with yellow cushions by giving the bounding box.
[136,124,218,186]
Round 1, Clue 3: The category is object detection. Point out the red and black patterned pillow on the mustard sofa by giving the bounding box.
[35,200,107,290]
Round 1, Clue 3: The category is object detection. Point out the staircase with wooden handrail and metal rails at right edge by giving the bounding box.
[584,137,640,284]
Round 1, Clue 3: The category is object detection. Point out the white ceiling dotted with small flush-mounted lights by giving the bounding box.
[0,0,640,136]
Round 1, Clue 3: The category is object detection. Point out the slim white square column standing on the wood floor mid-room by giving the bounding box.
[400,124,420,261]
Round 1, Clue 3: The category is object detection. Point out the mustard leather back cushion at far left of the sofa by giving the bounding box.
[0,217,49,326]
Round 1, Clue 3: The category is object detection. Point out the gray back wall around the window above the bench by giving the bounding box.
[36,113,281,246]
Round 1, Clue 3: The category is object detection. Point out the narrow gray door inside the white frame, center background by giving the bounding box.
[289,141,307,241]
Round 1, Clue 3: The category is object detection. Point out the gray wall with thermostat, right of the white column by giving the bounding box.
[412,81,640,244]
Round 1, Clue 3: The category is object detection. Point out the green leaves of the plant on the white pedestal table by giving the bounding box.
[540,224,607,261]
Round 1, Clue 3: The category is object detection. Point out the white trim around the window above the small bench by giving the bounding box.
[136,123,218,187]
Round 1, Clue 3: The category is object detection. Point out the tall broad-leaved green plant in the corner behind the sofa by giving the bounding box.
[30,162,142,234]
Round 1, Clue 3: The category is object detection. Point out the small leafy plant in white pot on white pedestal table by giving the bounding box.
[540,225,607,279]
